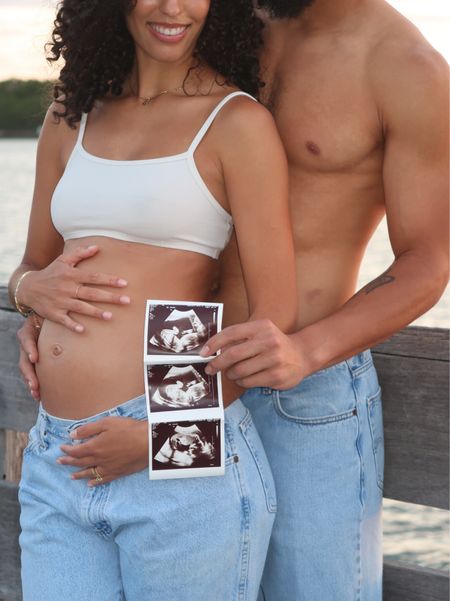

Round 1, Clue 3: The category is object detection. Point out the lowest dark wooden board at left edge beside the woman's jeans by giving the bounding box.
[0,482,22,601]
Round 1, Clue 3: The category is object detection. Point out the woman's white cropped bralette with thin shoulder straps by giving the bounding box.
[51,92,254,259]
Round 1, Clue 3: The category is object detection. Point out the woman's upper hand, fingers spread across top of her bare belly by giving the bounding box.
[19,245,130,333]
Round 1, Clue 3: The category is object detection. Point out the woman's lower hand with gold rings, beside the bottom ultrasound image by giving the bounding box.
[58,416,148,486]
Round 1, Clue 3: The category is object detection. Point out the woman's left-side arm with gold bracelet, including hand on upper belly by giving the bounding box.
[8,105,128,332]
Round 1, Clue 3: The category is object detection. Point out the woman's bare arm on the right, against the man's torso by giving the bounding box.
[220,97,297,331]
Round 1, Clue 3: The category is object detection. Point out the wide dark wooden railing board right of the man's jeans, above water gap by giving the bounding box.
[374,354,449,509]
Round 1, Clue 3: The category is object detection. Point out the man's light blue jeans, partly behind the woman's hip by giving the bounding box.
[242,351,384,601]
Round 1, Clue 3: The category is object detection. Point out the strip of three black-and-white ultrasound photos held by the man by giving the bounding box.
[144,300,225,480]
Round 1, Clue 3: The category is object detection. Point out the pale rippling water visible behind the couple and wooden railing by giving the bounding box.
[0,139,450,568]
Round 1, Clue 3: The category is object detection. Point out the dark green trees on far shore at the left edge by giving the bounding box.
[0,79,52,136]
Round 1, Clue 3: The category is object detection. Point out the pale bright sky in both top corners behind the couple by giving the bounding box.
[0,0,450,80]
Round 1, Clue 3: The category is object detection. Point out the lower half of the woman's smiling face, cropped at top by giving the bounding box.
[127,0,211,62]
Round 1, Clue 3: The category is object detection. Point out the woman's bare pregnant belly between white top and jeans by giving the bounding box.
[37,237,243,419]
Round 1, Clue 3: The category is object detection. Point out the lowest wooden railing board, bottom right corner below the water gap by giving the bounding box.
[383,562,449,601]
